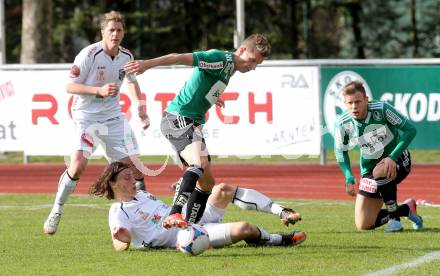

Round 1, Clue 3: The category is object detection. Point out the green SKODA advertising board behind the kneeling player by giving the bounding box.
[321,65,440,149]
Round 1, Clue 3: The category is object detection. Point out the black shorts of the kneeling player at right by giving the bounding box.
[358,150,411,198]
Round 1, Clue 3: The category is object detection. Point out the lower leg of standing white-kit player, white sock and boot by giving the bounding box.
[43,170,78,235]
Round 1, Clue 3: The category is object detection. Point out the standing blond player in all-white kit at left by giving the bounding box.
[43,11,149,234]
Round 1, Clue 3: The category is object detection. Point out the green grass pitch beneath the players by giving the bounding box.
[0,194,440,275]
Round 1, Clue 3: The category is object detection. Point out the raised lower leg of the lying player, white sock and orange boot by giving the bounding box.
[232,187,301,226]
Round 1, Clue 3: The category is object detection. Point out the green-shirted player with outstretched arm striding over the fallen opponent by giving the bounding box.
[125,34,300,228]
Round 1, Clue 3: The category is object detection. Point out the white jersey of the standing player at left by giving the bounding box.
[69,41,136,121]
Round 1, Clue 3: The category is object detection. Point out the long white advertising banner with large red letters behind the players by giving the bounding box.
[0,66,321,156]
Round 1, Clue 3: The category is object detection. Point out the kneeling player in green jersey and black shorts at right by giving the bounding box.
[335,81,423,232]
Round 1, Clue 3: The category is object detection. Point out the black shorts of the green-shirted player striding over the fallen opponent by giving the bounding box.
[160,112,211,166]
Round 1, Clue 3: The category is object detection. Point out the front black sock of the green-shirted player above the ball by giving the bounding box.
[170,166,203,215]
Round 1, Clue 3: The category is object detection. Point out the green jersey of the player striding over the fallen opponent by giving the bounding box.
[166,50,235,124]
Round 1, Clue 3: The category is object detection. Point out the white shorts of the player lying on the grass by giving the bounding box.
[199,202,232,248]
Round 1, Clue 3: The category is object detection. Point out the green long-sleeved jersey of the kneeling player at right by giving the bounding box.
[334,101,416,183]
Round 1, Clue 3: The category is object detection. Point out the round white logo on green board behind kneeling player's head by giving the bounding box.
[323,71,373,136]
